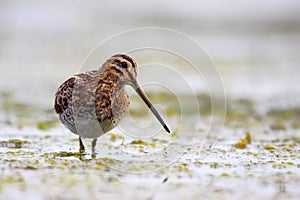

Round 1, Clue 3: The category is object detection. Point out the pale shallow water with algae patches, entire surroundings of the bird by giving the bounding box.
[0,0,300,199]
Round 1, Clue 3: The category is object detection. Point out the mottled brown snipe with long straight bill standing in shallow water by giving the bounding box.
[54,54,170,158]
